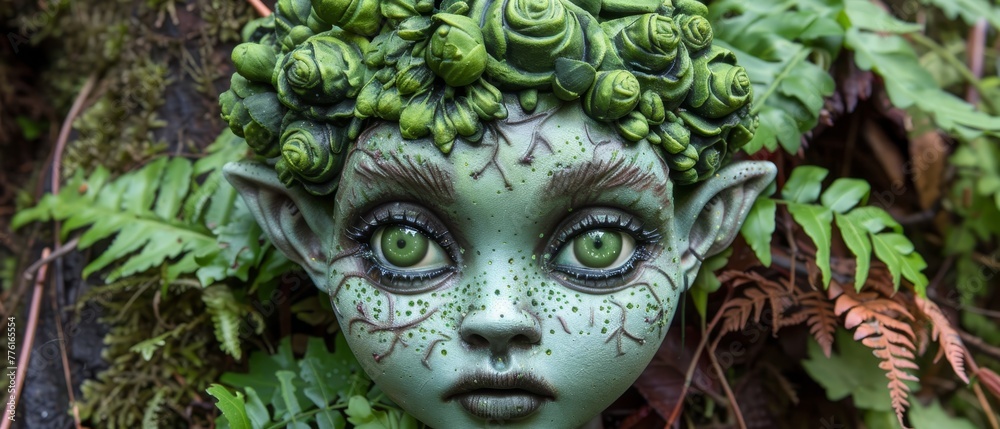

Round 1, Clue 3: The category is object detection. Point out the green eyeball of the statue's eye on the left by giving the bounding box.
[370,225,449,270]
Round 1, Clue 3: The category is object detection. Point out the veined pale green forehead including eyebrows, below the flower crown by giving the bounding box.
[339,103,672,211]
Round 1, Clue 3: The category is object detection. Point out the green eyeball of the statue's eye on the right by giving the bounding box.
[552,228,635,272]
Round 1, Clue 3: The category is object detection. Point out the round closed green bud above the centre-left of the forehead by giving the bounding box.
[426,13,487,86]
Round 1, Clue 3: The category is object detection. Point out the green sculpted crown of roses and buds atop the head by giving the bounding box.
[219,0,757,195]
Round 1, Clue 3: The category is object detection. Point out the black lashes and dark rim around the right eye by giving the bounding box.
[545,210,662,290]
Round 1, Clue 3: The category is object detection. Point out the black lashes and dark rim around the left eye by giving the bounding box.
[346,203,457,292]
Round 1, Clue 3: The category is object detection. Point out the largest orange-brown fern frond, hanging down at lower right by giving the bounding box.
[829,282,918,427]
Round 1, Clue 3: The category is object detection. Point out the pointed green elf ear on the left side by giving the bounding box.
[222,161,333,279]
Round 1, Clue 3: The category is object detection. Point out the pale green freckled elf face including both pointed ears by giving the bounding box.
[227,103,773,428]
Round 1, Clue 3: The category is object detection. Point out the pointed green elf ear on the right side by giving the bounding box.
[675,161,777,285]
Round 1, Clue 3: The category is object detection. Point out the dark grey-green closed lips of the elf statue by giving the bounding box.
[444,371,556,421]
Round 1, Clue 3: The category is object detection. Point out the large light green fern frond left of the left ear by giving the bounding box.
[14,158,216,283]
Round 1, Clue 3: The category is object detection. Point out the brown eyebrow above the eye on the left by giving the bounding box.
[346,149,455,204]
